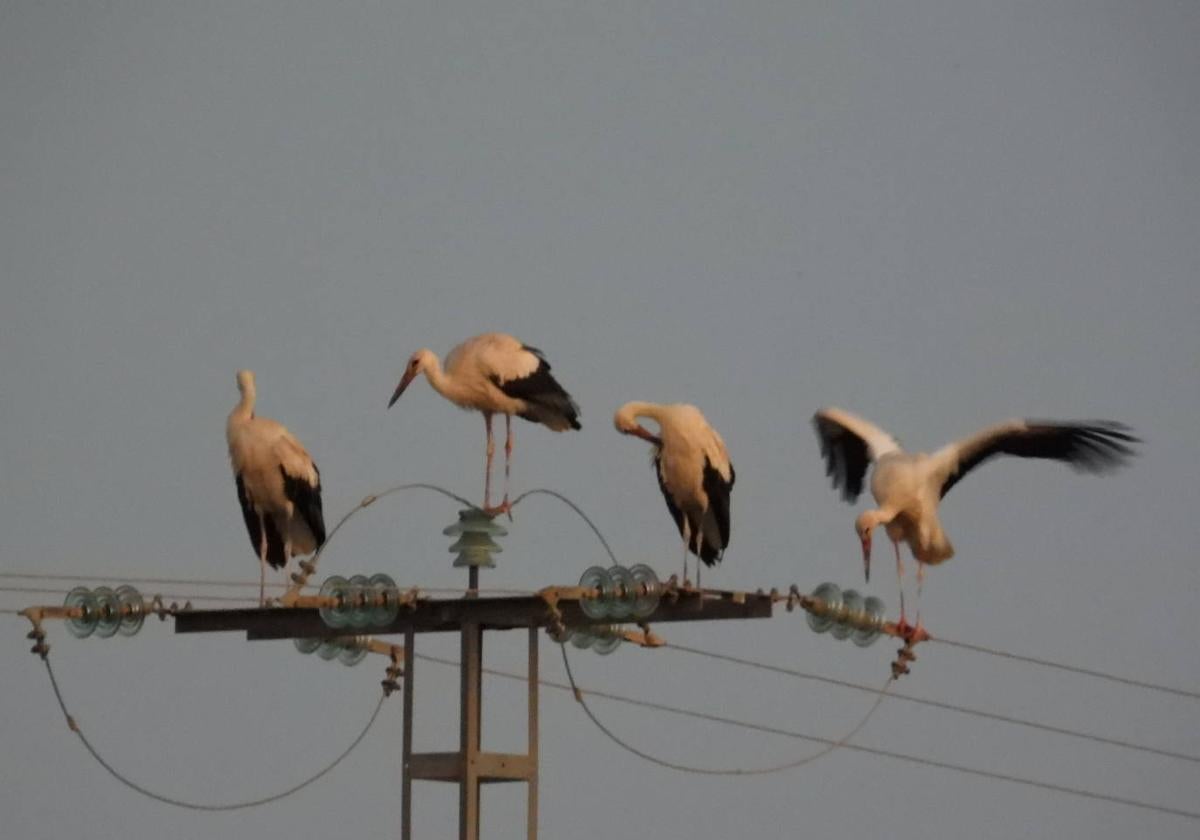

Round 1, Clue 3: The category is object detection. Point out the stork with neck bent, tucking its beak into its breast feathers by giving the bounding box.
[612,402,737,586]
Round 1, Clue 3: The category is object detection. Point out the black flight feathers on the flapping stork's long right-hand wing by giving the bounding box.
[942,420,1141,497]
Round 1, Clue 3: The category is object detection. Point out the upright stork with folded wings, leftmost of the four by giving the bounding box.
[226,371,325,604]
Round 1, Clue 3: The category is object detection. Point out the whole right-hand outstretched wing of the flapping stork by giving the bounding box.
[932,420,1141,497]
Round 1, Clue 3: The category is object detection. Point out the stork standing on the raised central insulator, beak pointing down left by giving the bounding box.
[388,332,580,515]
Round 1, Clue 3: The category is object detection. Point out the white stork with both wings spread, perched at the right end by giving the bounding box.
[812,408,1140,629]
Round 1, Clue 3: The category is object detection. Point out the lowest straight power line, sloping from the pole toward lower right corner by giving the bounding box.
[415,654,1200,820]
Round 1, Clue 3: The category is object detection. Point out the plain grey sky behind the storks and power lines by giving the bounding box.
[0,0,1200,840]
